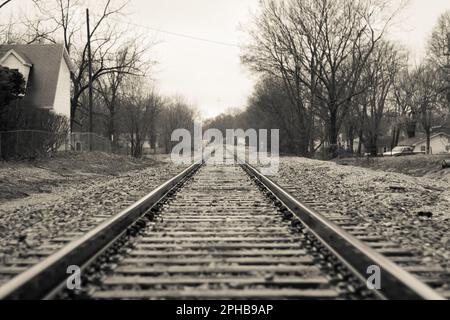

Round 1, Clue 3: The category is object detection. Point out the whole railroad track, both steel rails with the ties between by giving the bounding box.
[0,149,441,299]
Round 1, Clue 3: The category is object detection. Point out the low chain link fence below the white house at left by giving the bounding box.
[0,130,118,160]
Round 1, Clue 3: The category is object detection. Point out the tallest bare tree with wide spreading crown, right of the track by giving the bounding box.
[243,0,404,157]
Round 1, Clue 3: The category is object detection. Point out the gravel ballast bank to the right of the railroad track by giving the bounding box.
[273,157,450,270]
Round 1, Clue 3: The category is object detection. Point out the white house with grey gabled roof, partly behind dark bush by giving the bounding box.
[0,44,73,119]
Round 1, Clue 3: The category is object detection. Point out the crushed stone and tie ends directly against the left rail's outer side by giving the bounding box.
[0,166,184,286]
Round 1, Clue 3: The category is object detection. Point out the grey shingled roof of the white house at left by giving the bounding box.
[0,44,73,107]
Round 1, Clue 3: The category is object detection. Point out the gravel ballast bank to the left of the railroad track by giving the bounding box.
[0,162,185,284]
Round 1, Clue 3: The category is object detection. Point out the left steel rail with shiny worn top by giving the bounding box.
[0,160,203,300]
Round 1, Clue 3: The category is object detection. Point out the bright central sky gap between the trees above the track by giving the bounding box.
[125,0,258,117]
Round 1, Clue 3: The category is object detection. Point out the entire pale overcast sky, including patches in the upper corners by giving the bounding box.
[2,0,450,118]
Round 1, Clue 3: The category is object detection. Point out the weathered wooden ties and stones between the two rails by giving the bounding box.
[78,165,370,299]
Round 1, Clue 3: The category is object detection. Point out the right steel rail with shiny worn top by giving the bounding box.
[234,151,445,300]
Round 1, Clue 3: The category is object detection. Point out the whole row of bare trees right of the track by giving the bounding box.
[208,0,450,158]
